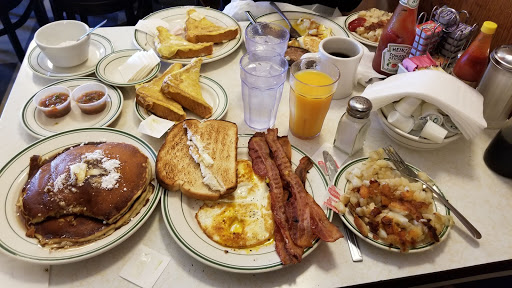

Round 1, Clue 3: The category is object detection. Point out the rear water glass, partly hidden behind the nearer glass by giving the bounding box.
[245,22,290,55]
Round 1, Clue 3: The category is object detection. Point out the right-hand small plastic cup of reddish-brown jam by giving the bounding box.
[71,83,108,115]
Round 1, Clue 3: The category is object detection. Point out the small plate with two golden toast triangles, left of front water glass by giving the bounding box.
[134,58,229,122]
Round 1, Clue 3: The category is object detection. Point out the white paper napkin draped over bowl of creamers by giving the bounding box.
[361,70,487,139]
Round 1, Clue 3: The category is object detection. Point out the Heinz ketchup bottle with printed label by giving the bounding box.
[372,0,420,76]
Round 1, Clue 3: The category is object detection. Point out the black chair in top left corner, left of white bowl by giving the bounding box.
[0,0,49,62]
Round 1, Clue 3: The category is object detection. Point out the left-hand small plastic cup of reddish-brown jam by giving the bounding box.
[32,86,71,118]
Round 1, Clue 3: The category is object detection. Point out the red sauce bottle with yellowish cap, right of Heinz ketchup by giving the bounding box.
[452,21,498,87]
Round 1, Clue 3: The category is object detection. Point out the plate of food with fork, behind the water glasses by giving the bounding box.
[256,11,350,63]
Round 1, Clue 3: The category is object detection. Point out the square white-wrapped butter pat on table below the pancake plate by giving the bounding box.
[119,246,171,288]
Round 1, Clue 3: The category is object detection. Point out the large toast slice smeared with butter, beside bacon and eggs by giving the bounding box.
[155,119,238,200]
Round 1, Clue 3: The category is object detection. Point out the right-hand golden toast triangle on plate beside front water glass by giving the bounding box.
[162,58,213,118]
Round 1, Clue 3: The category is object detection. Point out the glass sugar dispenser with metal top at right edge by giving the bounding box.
[477,45,512,128]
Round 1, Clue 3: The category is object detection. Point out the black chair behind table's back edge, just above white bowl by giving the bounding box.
[50,0,146,25]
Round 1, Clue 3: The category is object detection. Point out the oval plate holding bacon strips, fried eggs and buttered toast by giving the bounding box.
[159,124,342,273]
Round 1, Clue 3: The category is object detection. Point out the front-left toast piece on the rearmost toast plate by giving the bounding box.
[155,26,213,59]
